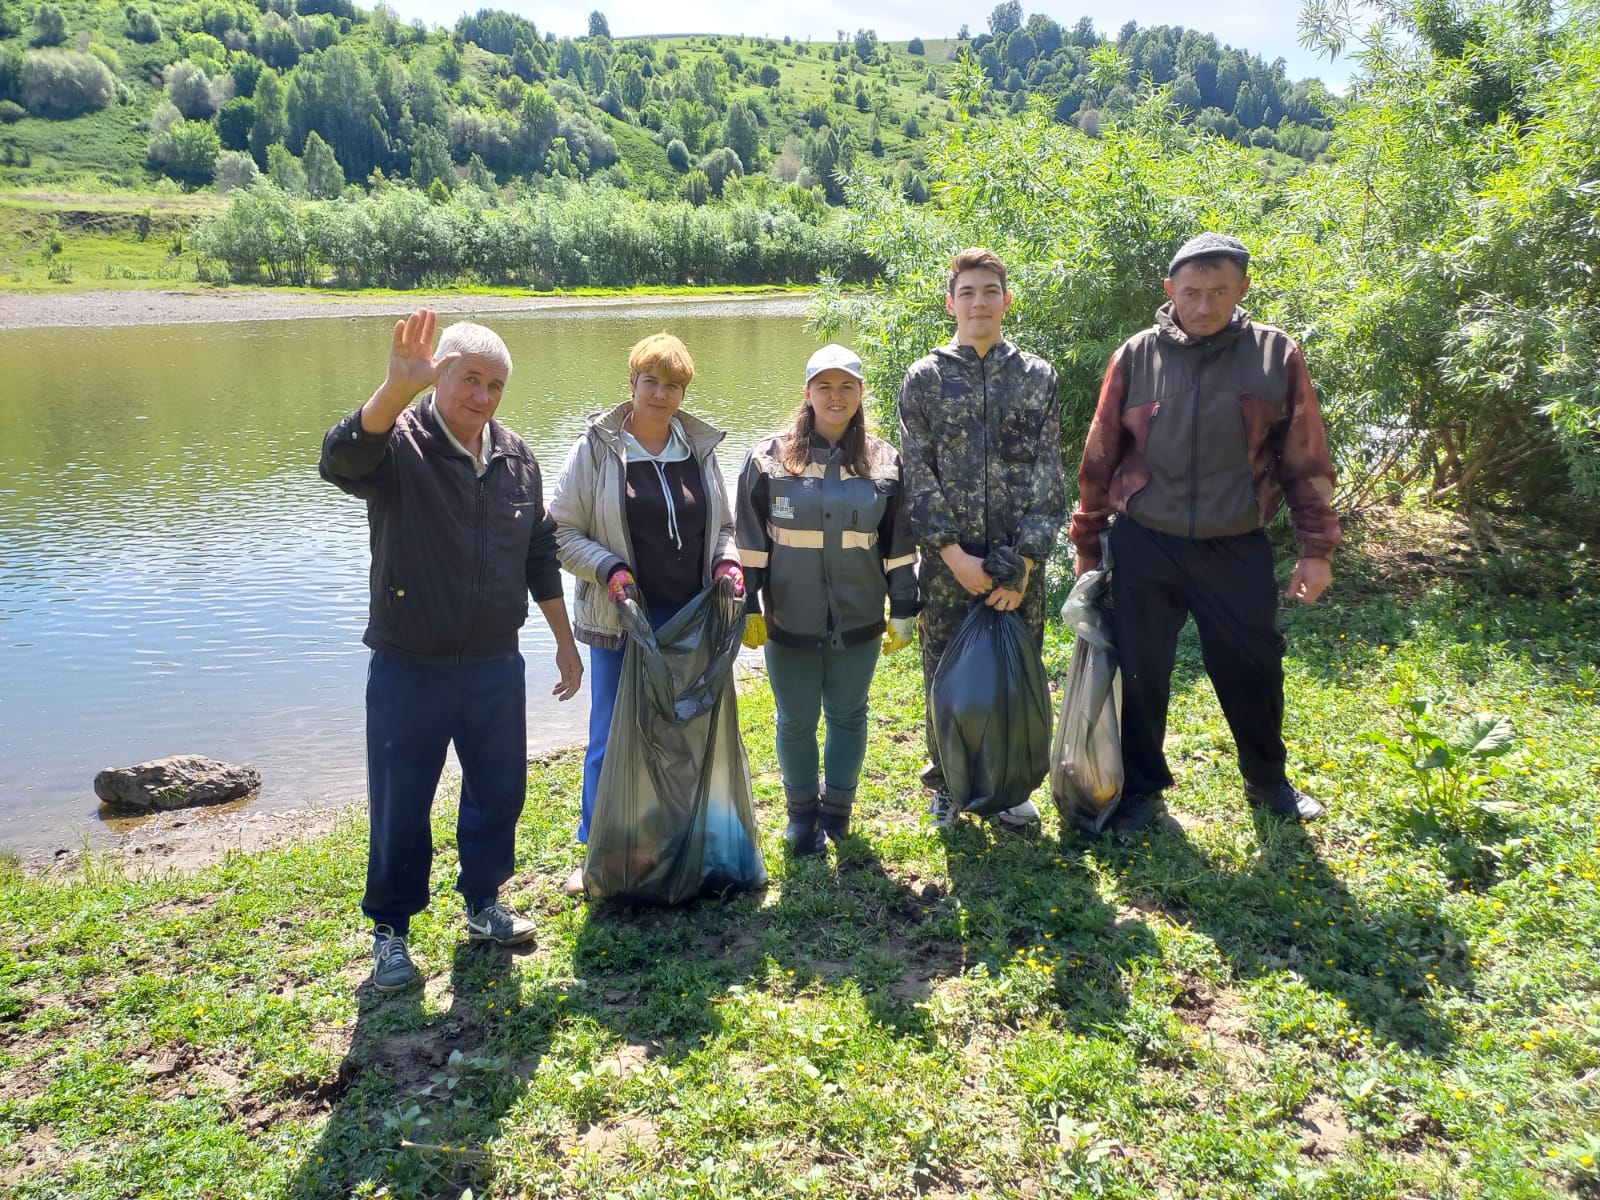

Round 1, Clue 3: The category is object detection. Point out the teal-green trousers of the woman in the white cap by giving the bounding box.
[766,637,882,792]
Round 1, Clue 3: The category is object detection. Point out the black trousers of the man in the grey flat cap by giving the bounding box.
[1110,517,1288,803]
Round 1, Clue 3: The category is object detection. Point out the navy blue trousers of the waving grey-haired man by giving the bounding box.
[362,651,528,934]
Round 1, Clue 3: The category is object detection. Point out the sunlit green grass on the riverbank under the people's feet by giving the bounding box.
[0,518,1600,1200]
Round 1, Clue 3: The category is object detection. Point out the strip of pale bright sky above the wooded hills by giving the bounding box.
[380,0,1350,91]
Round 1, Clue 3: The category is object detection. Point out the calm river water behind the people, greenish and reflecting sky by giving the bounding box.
[0,299,818,851]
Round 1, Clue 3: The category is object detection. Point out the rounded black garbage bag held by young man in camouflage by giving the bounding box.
[928,602,1051,816]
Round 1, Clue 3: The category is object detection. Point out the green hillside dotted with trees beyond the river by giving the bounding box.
[0,0,1336,203]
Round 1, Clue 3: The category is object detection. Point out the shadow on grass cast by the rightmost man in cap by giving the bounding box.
[1086,813,1472,1056]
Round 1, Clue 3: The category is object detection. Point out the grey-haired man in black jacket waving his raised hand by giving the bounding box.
[320,309,582,990]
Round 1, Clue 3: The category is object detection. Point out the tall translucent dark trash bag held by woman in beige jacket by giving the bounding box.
[584,581,766,904]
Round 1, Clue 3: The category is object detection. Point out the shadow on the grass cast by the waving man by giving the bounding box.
[288,942,560,1200]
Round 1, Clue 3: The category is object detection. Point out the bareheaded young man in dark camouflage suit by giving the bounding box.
[899,248,1067,827]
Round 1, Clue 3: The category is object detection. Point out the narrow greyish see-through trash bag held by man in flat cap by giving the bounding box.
[1050,550,1123,834]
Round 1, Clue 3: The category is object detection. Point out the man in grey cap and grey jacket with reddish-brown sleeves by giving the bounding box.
[1070,234,1339,832]
